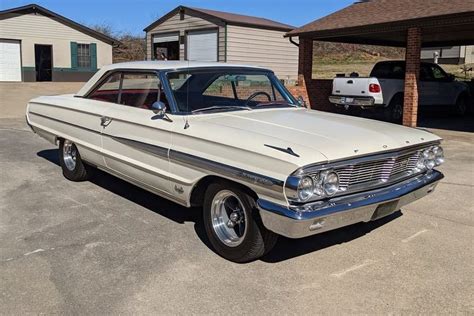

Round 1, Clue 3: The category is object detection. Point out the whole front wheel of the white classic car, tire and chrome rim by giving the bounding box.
[203,182,278,263]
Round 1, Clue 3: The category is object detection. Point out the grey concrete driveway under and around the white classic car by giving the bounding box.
[0,115,474,314]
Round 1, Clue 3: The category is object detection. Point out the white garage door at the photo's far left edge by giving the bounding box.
[0,40,21,81]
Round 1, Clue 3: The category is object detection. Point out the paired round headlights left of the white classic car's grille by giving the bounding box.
[295,170,339,202]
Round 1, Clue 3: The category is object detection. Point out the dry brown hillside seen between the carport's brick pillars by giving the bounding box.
[313,42,405,64]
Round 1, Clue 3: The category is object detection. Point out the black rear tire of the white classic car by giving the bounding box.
[59,139,90,182]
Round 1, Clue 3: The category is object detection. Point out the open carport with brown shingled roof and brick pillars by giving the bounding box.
[286,0,474,127]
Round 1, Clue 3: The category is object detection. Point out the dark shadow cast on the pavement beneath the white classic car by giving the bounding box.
[37,149,403,263]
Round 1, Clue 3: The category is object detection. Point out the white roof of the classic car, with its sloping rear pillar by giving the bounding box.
[76,60,271,96]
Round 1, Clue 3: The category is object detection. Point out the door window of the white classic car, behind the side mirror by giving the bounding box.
[120,72,167,109]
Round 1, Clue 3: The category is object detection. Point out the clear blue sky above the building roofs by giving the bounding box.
[0,0,355,34]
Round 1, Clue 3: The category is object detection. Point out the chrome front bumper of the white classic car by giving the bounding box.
[257,171,444,238]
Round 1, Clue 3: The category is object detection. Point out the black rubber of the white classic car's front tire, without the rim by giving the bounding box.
[203,181,278,263]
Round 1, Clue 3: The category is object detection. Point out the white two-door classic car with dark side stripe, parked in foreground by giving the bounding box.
[27,61,444,262]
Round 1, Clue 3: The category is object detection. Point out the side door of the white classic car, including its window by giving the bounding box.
[102,71,174,195]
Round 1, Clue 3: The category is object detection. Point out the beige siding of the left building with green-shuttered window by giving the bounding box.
[0,13,112,81]
